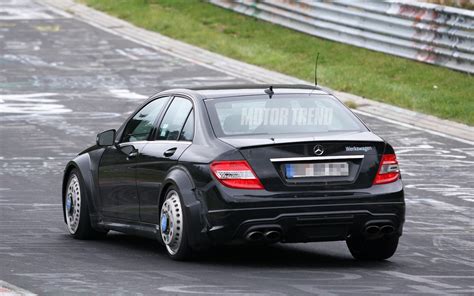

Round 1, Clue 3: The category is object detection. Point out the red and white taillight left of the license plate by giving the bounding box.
[211,160,263,189]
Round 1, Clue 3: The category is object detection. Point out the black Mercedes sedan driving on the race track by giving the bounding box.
[62,85,405,260]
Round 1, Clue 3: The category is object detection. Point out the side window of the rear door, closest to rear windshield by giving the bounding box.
[156,97,193,140]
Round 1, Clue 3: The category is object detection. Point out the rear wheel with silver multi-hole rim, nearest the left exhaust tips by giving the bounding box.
[159,186,192,261]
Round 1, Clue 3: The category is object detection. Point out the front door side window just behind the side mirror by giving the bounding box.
[122,97,169,142]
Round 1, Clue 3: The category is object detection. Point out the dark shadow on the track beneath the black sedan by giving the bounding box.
[85,232,397,268]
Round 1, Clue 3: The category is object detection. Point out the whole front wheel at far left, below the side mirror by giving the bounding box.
[64,169,107,239]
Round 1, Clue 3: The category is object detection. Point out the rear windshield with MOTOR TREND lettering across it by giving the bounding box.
[205,94,367,137]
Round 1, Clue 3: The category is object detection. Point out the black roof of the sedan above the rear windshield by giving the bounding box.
[163,84,330,99]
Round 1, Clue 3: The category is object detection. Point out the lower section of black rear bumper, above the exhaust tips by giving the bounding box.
[208,202,405,243]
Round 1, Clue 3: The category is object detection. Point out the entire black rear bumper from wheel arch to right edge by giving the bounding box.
[185,184,405,245]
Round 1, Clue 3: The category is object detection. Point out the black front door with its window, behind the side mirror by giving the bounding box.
[99,97,169,221]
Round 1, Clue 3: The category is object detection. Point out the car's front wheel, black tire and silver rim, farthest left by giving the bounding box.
[63,169,107,240]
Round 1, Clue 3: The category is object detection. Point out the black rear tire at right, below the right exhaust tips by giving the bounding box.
[346,236,398,261]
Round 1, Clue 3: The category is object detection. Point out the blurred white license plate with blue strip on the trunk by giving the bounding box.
[285,162,349,178]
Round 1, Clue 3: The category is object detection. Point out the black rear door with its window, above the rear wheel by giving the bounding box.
[137,97,194,224]
